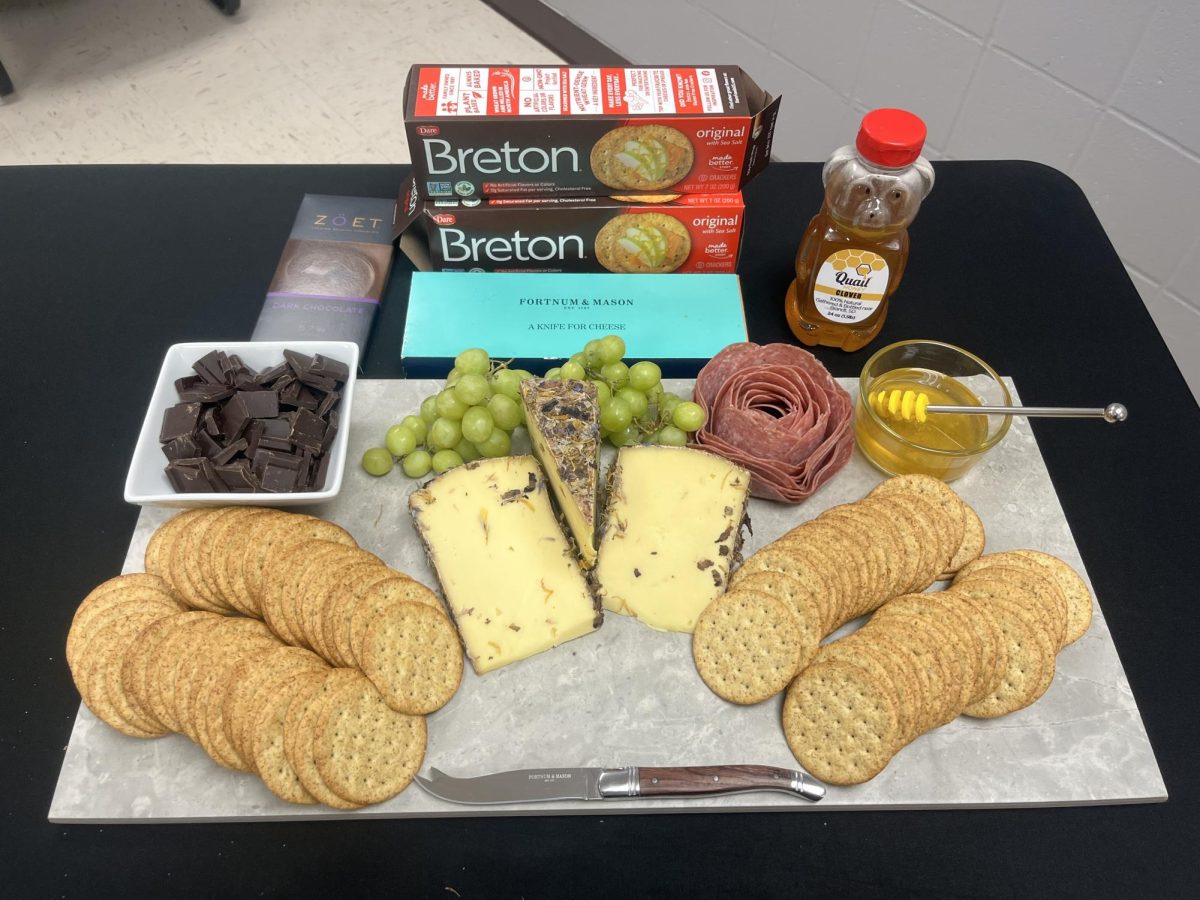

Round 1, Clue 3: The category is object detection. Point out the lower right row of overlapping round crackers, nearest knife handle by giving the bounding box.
[782,550,1092,785]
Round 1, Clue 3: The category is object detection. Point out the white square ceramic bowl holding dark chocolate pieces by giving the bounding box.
[125,341,359,508]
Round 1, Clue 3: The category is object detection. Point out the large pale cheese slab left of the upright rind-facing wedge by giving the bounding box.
[408,456,604,674]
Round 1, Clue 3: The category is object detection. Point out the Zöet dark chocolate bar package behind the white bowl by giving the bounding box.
[251,193,396,350]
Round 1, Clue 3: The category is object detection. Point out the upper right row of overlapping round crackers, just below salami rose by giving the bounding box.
[692,475,984,703]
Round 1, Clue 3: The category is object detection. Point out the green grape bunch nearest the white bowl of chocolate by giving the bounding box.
[362,347,534,478]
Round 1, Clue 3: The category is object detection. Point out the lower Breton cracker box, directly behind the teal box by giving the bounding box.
[396,178,745,275]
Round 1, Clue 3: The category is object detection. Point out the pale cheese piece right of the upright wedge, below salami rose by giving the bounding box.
[595,446,750,632]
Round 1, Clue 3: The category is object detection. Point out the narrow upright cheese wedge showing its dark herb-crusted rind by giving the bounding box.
[521,378,600,569]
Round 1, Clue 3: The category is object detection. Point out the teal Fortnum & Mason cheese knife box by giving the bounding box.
[401,272,746,378]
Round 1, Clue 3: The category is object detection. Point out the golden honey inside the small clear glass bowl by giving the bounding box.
[854,367,989,481]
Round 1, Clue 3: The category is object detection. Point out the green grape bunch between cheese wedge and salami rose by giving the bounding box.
[546,335,707,446]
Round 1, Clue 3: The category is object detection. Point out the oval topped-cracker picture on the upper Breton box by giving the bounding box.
[592,125,696,191]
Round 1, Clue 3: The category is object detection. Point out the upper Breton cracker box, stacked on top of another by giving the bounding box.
[404,65,779,199]
